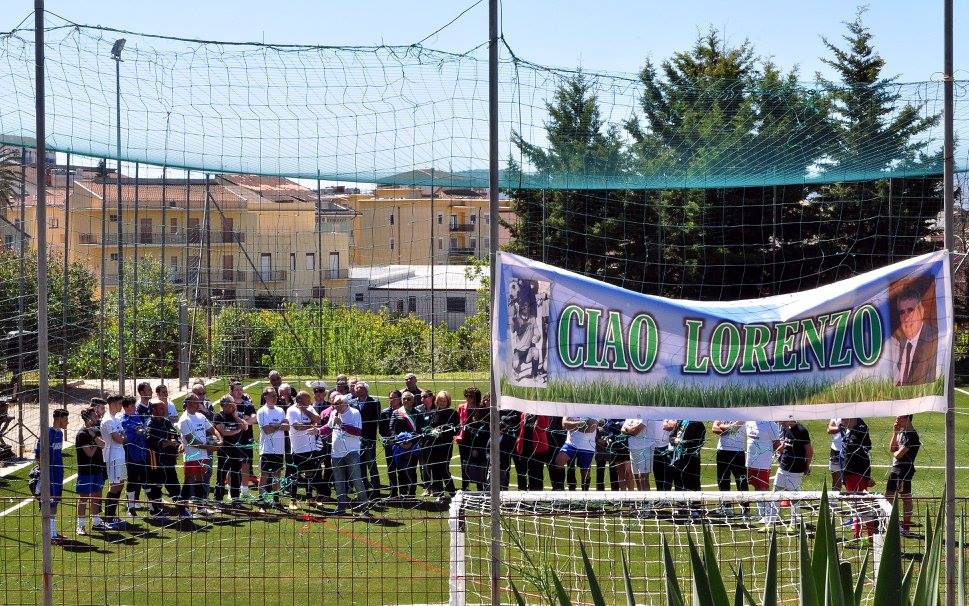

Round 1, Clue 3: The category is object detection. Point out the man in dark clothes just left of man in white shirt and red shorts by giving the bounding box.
[145,400,189,518]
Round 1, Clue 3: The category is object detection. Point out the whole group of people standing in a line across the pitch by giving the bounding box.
[32,371,920,537]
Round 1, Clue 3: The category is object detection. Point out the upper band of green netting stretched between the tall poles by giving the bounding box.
[0,18,969,189]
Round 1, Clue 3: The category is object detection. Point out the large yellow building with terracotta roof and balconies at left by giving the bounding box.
[26,175,354,304]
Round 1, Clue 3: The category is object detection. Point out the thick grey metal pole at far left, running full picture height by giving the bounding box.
[34,0,54,606]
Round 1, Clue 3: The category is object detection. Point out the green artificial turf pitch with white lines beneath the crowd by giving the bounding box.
[0,375,969,605]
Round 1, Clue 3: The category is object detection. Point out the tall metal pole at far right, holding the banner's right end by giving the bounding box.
[942,0,956,606]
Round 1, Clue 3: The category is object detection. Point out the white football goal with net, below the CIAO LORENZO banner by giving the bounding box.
[450,491,891,605]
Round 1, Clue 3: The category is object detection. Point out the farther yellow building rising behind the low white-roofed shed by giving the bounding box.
[348,170,508,267]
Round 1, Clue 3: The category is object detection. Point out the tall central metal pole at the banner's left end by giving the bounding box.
[488,0,501,606]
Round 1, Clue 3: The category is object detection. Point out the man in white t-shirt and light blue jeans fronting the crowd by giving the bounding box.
[327,395,367,514]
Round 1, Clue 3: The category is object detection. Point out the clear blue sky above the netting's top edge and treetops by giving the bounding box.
[28,0,969,81]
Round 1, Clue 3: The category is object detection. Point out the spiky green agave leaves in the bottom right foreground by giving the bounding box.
[511,490,940,606]
